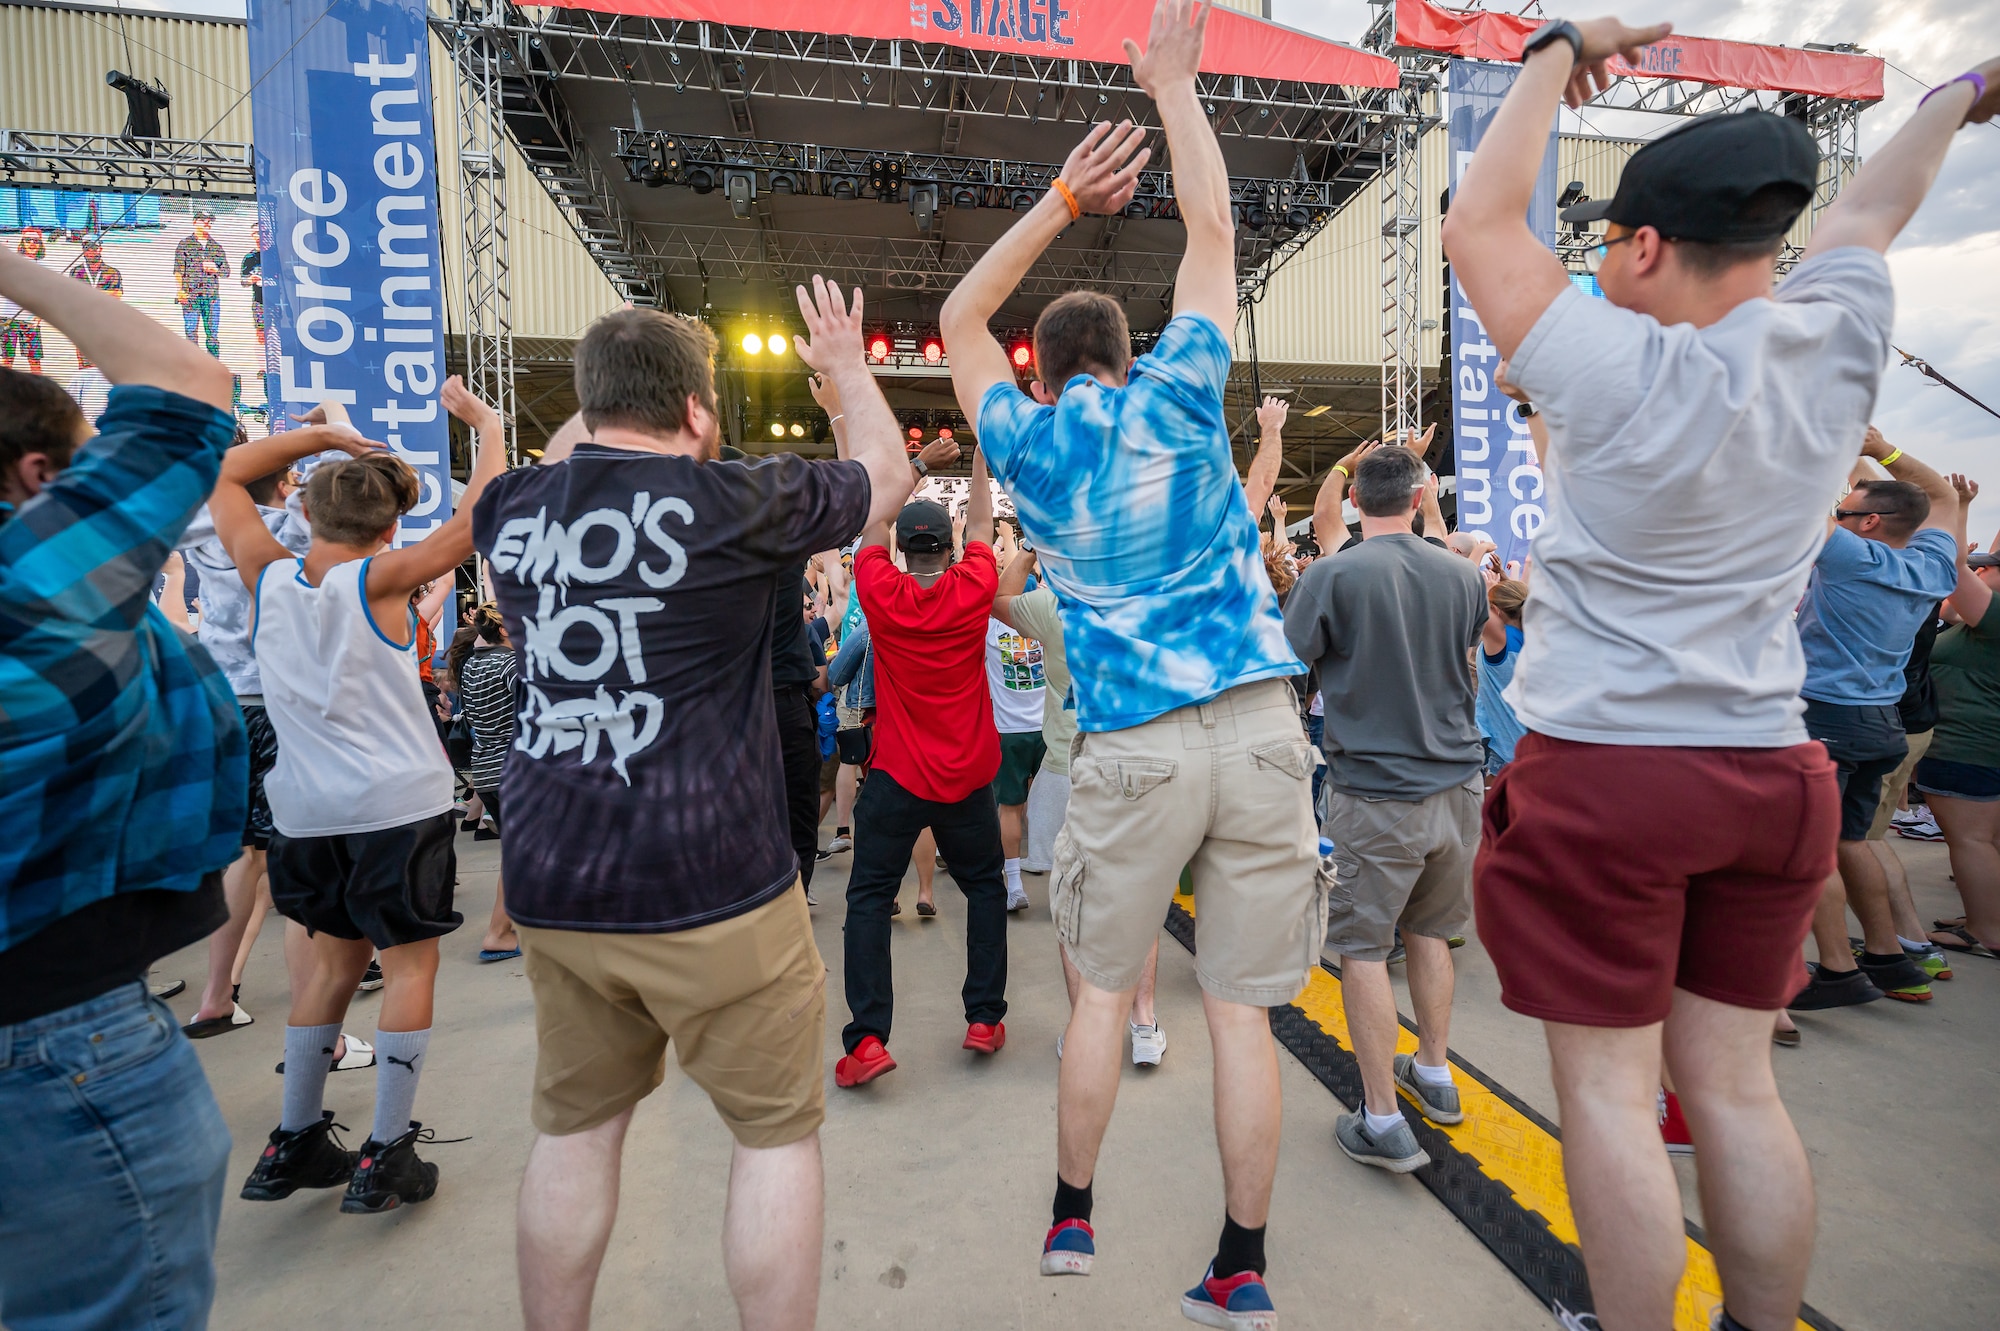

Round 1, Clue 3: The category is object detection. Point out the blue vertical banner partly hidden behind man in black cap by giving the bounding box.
[1446,60,1558,568]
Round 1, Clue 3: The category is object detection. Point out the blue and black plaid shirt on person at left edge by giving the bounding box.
[0,388,250,951]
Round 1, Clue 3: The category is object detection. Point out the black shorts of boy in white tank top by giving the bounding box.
[270,811,464,947]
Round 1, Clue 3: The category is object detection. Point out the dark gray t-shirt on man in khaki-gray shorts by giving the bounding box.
[1284,534,1486,799]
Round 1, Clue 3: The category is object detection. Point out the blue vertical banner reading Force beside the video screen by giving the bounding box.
[250,0,452,546]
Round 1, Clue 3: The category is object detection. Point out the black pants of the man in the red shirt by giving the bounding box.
[840,767,1006,1053]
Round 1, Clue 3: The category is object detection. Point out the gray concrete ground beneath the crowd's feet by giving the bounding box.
[168,835,2000,1331]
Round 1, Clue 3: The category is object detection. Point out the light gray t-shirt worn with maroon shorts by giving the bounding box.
[1506,248,1894,747]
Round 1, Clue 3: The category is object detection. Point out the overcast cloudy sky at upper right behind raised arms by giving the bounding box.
[1272,0,2000,542]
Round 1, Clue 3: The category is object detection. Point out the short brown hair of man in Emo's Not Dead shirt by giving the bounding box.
[576,308,716,434]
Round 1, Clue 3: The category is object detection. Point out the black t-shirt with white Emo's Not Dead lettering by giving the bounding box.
[472,444,868,933]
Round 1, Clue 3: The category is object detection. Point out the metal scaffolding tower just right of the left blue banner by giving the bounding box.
[450,0,520,462]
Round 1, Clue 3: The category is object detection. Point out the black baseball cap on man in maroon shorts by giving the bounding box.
[1562,110,1820,242]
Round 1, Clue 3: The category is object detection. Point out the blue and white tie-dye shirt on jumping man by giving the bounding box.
[978,314,1306,731]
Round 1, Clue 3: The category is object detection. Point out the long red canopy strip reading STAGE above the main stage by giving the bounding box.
[572,0,1402,88]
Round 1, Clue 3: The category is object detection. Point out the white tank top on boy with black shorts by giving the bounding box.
[250,560,452,837]
